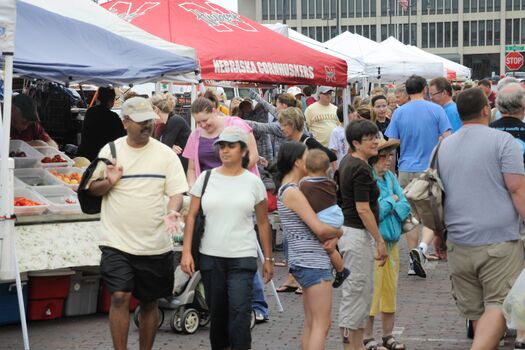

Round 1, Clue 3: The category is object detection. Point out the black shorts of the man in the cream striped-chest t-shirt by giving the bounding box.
[100,247,173,301]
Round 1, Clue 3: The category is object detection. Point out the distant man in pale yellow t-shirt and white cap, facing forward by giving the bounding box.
[304,86,339,147]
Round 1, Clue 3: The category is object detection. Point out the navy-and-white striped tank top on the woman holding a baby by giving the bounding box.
[277,183,332,269]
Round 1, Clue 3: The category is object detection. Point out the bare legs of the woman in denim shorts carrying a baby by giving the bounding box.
[302,281,332,350]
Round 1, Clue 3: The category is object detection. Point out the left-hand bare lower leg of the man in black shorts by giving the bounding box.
[109,292,131,350]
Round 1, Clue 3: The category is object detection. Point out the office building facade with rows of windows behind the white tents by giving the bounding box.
[239,0,525,79]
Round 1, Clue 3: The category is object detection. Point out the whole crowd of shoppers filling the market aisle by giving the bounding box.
[81,76,525,350]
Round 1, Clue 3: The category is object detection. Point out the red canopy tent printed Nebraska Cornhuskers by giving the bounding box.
[102,0,347,86]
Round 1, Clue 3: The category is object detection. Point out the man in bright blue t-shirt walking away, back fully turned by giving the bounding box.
[385,75,451,278]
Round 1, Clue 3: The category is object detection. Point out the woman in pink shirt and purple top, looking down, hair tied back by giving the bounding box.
[182,97,259,187]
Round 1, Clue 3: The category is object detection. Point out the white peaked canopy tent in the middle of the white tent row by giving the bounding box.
[324,32,443,82]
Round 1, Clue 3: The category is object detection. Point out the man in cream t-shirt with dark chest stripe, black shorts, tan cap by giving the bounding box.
[87,97,188,349]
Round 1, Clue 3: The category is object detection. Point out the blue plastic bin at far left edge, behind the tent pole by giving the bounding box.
[0,274,27,326]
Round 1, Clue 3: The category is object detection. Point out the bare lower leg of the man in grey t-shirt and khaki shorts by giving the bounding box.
[470,309,506,350]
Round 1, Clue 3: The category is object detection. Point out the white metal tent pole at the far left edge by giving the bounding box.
[0,52,29,350]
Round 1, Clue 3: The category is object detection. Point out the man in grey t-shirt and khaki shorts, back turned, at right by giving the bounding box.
[438,88,525,349]
